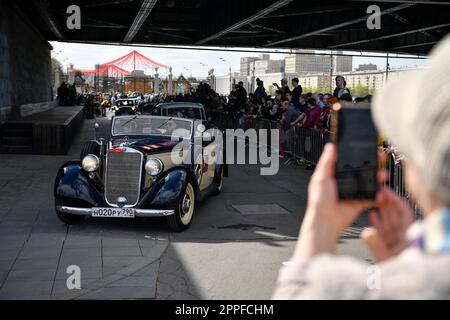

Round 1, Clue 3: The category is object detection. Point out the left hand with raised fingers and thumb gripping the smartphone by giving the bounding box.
[293,144,375,260]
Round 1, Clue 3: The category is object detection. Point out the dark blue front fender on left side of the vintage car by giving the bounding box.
[54,161,105,206]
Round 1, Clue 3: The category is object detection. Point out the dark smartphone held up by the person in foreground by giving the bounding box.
[332,102,378,200]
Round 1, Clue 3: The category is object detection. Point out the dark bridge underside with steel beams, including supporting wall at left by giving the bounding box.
[0,0,450,139]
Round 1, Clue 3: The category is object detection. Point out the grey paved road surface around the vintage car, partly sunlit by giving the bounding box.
[0,111,371,299]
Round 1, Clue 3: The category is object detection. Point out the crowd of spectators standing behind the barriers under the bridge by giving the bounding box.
[58,76,372,131]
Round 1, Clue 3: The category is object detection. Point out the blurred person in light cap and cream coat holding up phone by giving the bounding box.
[273,36,450,299]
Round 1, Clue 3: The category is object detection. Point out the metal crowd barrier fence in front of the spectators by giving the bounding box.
[243,118,422,219]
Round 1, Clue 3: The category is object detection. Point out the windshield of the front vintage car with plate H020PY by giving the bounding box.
[112,116,192,139]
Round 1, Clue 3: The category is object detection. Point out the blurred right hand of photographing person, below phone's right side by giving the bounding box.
[361,187,414,261]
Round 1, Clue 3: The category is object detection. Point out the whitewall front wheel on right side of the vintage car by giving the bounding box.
[167,182,195,232]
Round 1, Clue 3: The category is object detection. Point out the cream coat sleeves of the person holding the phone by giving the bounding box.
[273,247,450,300]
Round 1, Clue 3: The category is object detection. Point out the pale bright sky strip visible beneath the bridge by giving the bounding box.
[50,42,425,78]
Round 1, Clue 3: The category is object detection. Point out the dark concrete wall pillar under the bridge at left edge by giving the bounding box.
[0,1,52,125]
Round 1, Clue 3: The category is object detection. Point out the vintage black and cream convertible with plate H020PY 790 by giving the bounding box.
[54,115,227,231]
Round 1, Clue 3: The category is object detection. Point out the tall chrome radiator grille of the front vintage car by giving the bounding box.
[105,152,143,206]
